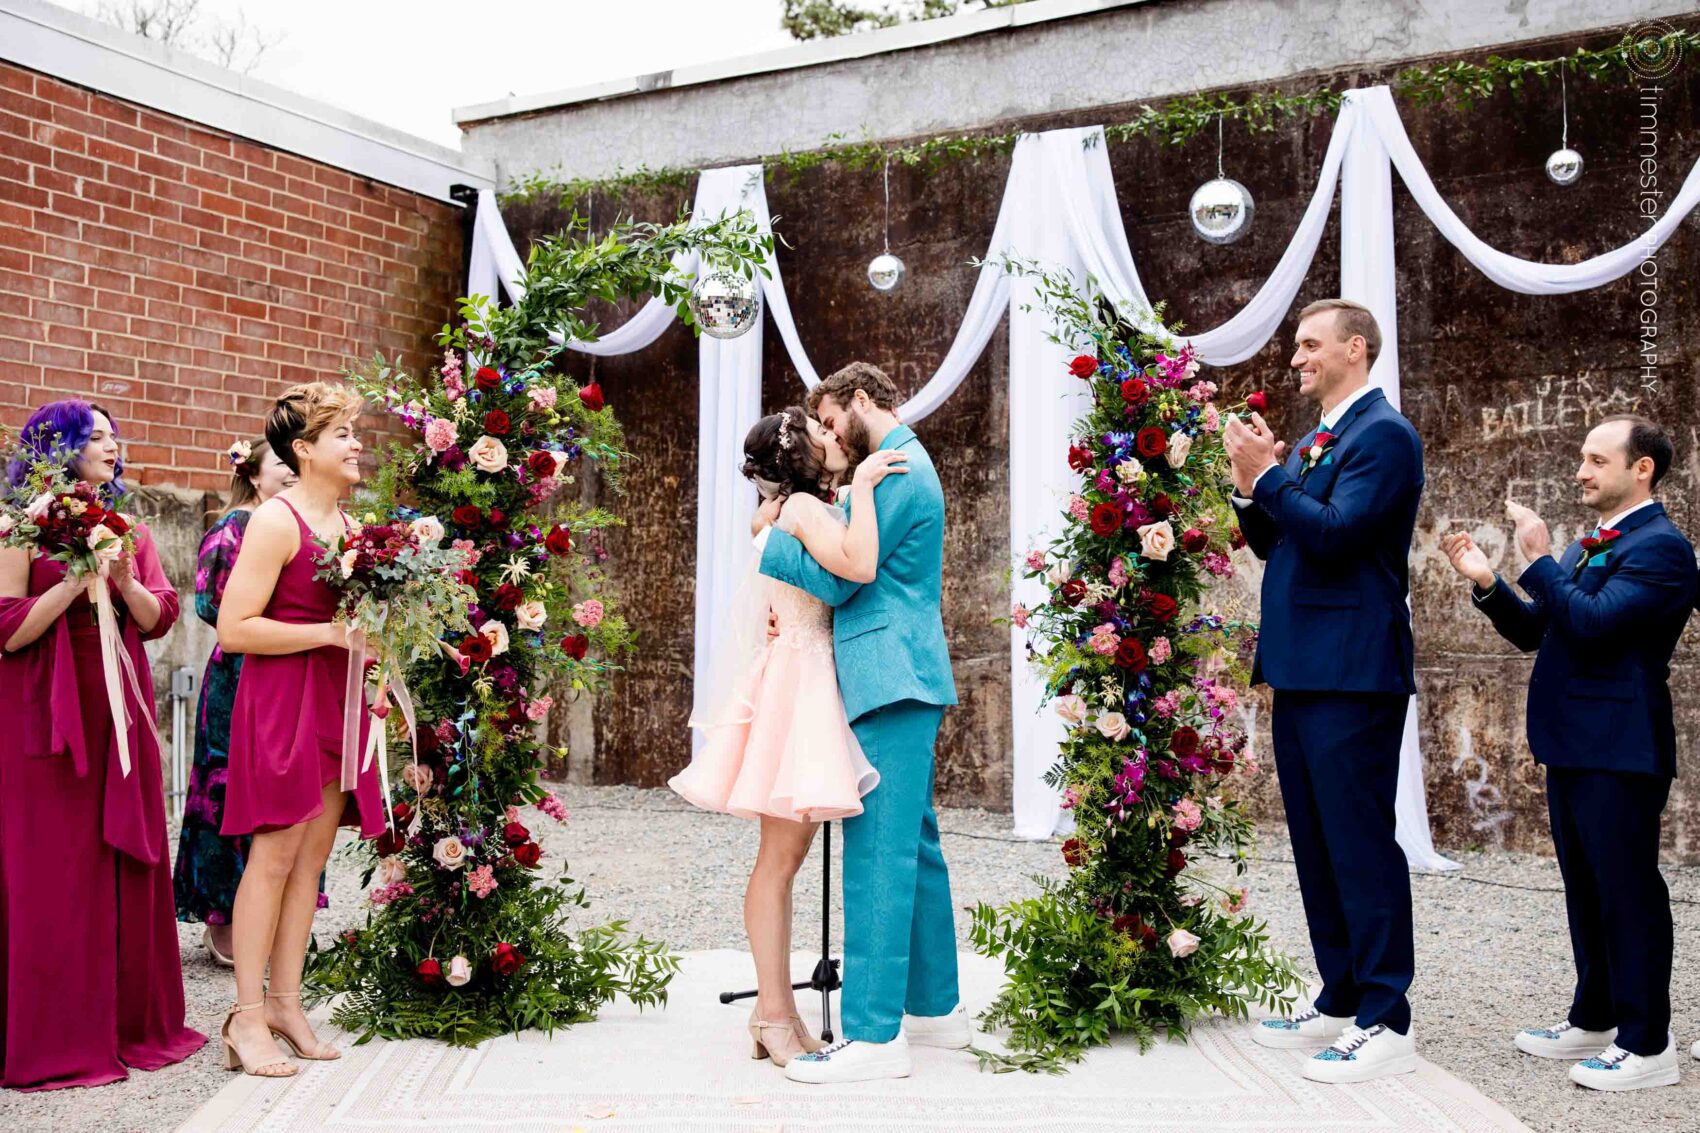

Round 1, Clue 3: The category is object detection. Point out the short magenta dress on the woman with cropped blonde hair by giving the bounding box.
[219,497,384,839]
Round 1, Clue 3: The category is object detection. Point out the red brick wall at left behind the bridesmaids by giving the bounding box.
[0,63,462,492]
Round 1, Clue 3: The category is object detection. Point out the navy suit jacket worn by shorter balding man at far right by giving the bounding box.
[1472,504,1697,777]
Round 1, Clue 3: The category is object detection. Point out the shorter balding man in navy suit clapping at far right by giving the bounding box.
[1442,415,1695,1090]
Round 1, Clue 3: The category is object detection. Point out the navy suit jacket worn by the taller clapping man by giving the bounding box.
[1239,390,1423,694]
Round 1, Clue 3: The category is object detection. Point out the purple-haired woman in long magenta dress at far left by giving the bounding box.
[0,401,206,1090]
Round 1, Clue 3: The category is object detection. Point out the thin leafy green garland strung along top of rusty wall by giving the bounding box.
[502,29,1700,208]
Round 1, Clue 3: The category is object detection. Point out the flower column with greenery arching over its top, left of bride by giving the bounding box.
[308,213,772,1045]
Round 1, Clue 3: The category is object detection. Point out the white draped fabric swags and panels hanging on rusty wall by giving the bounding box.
[468,87,1700,869]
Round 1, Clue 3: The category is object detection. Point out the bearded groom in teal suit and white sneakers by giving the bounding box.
[762,362,969,1082]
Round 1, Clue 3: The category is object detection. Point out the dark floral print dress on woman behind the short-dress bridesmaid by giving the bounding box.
[172,509,326,924]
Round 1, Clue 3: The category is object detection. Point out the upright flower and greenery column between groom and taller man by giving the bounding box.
[969,262,1299,1072]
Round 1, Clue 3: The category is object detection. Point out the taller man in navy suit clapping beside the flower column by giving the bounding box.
[1222,299,1423,1082]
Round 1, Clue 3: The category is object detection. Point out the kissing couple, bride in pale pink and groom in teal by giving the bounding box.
[668,362,971,1082]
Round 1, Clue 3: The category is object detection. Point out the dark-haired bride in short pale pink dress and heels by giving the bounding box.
[668,407,908,1067]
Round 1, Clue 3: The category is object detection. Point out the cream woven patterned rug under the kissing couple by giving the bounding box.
[182,951,1523,1133]
